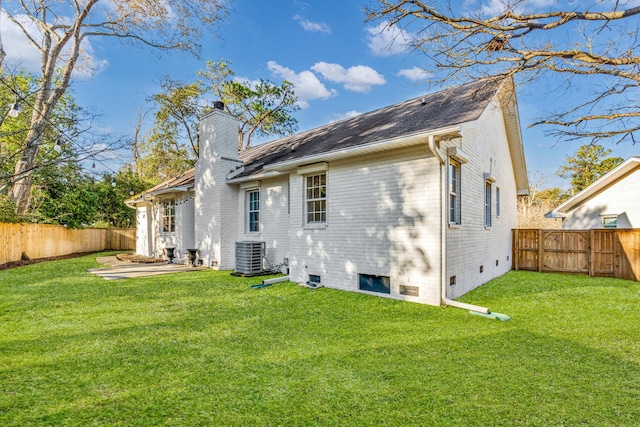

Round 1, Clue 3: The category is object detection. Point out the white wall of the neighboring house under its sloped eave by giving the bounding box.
[562,170,640,230]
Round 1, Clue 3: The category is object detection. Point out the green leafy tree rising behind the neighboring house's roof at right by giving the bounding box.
[558,144,623,193]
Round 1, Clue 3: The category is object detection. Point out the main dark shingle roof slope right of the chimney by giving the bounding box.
[238,80,499,177]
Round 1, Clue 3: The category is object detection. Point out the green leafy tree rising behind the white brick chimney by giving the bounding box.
[138,60,299,184]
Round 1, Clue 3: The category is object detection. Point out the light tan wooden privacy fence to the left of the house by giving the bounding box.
[0,223,136,264]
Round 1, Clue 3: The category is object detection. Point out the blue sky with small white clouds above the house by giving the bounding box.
[2,0,640,186]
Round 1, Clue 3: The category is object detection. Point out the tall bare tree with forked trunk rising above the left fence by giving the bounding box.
[5,0,228,214]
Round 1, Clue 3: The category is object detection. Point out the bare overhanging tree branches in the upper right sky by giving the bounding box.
[367,0,640,143]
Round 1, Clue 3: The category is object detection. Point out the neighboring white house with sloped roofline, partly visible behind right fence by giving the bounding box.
[545,156,640,230]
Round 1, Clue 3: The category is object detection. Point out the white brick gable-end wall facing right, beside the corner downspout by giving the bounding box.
[447,100,517,299]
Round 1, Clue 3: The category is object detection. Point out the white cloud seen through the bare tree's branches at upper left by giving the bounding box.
[0,11,109,80]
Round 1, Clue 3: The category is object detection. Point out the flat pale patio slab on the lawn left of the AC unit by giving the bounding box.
[87,256,209,280]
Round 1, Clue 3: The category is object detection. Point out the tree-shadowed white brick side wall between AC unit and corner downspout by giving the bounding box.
[290,145,440,304]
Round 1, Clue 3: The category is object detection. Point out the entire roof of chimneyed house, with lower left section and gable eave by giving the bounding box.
[127,80,529,204]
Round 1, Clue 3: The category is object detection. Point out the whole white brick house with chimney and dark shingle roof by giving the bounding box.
[127,81,528,305]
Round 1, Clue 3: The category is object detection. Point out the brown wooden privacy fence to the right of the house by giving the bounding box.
[513,228,640,280]
